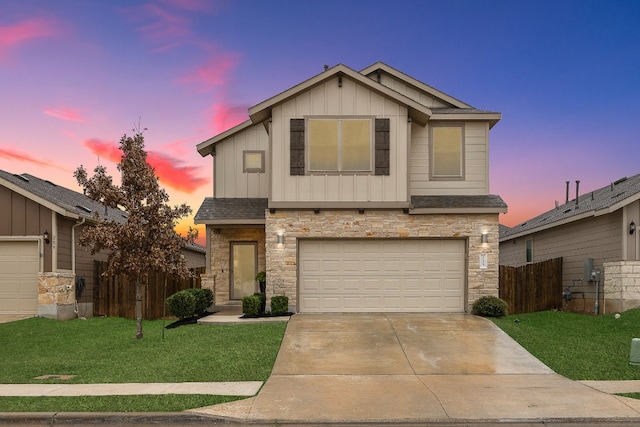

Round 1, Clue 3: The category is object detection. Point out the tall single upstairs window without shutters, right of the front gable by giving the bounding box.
[431,125,464,179]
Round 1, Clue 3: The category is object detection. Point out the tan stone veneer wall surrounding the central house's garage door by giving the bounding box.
[265,210,499,312]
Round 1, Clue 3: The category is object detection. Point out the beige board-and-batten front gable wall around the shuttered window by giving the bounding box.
[269,77,409,207]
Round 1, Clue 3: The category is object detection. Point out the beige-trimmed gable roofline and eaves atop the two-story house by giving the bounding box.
[197,62,501,157]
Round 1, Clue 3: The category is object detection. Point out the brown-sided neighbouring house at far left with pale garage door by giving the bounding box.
[0,170,204,320]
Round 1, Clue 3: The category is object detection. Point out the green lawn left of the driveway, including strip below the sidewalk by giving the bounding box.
[0,317,286,412]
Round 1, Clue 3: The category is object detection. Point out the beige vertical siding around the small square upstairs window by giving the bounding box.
[214,123,269,198]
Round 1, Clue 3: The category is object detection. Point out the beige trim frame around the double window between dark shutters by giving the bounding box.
[304,116,376,175]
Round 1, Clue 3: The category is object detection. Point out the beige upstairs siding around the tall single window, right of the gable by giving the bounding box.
[409,121,489,196]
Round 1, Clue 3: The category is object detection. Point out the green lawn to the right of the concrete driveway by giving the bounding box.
[492,310,640,380]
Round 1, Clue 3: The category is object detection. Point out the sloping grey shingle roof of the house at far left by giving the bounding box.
[0,170,127,223]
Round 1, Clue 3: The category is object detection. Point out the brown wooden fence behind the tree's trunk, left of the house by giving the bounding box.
[93,261,205,320]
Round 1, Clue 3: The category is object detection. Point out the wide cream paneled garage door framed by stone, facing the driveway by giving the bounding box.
[298,239,466,313]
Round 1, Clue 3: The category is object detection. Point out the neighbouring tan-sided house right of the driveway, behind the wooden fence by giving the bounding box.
[500,174,640,313]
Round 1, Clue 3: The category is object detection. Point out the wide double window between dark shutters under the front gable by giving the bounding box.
[307,118,372,172]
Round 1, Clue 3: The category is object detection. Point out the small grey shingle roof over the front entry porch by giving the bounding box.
[194,197,268,224]
